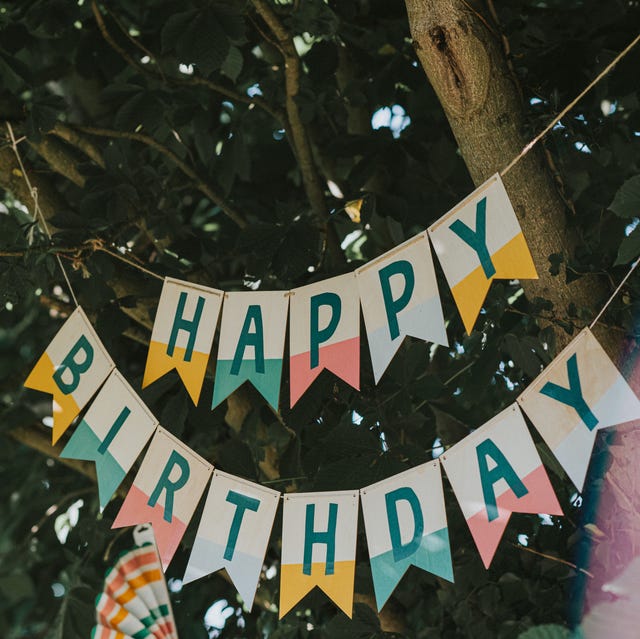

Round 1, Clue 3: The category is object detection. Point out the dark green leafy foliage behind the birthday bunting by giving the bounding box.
[0,0,640,639]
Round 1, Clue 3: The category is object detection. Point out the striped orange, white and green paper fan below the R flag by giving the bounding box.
[92,544,178,639]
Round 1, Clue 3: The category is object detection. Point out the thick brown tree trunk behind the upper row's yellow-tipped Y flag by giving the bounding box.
[406,0,619,355]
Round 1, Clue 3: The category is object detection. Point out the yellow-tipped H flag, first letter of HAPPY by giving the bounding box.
[142,277,224,404]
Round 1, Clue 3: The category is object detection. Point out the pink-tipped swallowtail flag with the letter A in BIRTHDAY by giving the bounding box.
[440,404,562,568]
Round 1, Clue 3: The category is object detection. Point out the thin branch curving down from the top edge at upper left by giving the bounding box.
[91,0,286,126]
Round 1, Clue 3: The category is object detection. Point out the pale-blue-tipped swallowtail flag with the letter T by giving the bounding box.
[183,470,280,609]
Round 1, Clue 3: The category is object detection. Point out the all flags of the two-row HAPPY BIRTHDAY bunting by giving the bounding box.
[25,175,640,617]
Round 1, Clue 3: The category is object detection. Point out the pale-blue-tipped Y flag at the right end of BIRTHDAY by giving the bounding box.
[518,328,640,490]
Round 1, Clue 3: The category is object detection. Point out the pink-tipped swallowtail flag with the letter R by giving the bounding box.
[112,426,213,570]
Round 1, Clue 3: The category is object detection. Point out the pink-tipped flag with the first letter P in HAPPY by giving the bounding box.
[289,273,360,406]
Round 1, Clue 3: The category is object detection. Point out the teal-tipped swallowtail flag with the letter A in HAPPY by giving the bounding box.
[211,291,289,410]
